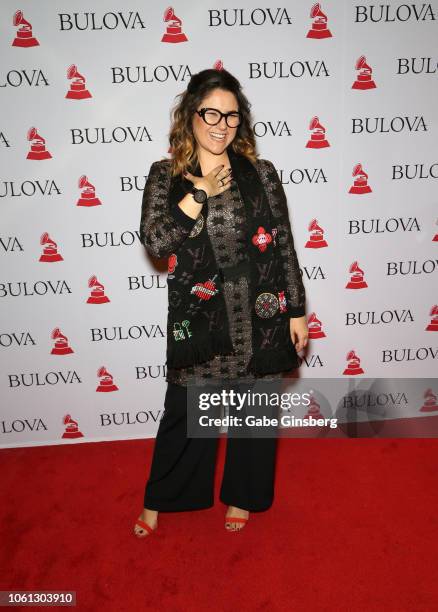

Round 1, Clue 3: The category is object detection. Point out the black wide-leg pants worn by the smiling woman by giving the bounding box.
[144,382,277,512]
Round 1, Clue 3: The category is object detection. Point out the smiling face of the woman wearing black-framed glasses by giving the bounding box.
[192,88,239,155]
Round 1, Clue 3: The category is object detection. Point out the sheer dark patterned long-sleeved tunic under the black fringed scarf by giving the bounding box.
[140,159,305,385]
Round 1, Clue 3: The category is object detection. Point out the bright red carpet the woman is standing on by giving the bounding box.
[0,439,438,612]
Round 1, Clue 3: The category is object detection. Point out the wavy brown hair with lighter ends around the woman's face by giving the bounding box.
[169,68,258,176]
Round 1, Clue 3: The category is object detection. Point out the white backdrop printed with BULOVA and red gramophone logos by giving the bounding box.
[0,0,438,447]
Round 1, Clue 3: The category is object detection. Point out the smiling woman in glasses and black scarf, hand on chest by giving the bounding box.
[134,69,308,537]
